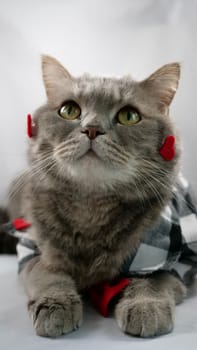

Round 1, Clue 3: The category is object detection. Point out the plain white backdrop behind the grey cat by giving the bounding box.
[0,0,197,202]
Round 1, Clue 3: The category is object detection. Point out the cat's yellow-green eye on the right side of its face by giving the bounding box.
[117,106,141,126]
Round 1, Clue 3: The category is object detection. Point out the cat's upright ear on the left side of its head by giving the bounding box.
[42,55,72,104]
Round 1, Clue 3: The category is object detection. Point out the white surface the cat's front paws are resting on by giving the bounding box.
[0,256,197,350]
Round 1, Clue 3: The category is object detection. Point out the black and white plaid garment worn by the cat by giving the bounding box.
[17,175,197,282]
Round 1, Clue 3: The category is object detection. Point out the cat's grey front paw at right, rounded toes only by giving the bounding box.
[115,297,175,337]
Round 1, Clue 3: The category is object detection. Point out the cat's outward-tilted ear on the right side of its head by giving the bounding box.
[141,62,181,112]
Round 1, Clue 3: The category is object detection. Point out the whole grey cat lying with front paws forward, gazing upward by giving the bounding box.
[3,56,195,337]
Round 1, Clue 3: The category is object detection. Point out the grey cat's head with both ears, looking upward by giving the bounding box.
[30,56,180,197]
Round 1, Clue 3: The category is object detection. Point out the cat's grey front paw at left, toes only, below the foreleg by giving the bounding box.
[28,295,82,337]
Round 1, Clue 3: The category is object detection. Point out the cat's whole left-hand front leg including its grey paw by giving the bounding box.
[20,257,82,337]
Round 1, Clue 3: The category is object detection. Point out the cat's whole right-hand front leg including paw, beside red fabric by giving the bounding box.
[115,273,186,337]
